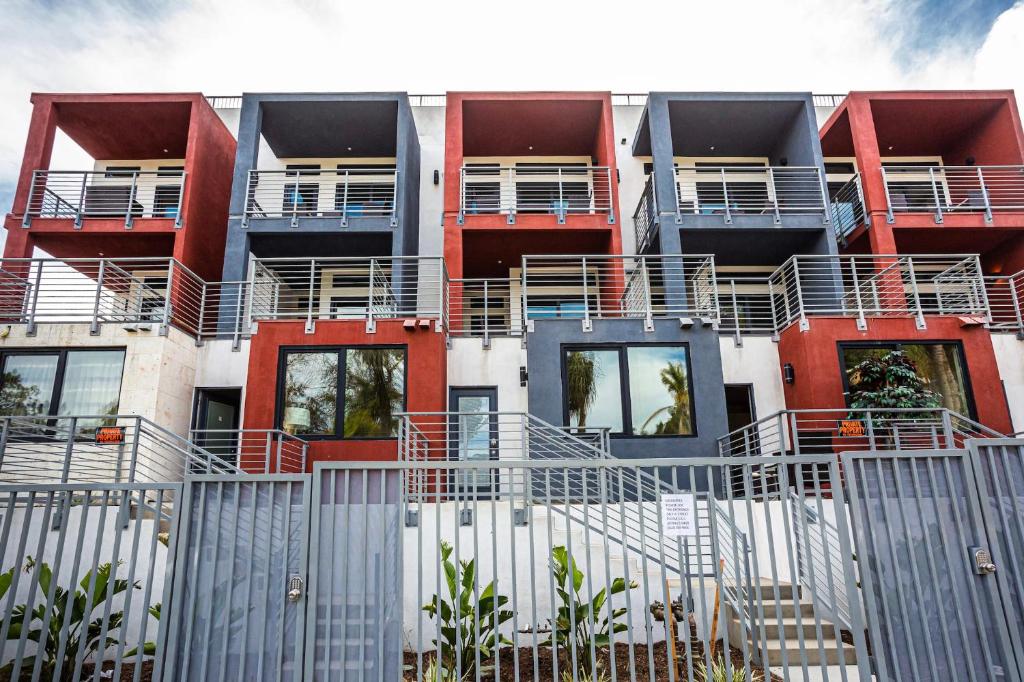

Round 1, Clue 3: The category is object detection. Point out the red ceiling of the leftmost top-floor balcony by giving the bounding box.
[55,100,191,160]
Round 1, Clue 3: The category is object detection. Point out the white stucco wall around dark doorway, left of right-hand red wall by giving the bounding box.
[719,336,785,419]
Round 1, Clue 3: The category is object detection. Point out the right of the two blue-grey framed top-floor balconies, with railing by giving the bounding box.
[633,92,831,253]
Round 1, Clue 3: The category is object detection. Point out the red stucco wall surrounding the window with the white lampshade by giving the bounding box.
[243,319,447,469]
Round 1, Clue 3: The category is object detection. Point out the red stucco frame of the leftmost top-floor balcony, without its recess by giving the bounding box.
[4,93,236,279]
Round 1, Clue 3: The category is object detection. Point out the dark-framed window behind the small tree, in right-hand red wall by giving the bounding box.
[839,341,977,419]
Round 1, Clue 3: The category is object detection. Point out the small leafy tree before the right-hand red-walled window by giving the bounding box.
[849,350,942,422]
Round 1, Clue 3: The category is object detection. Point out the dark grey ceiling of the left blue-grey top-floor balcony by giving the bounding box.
[260,100,398,159]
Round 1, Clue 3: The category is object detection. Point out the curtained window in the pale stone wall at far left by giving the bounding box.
[0,349,125,431]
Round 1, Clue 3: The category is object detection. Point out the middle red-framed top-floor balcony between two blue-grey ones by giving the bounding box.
[444,92,618,232]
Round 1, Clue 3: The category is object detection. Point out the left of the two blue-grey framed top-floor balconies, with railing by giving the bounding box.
[231,93,419,236]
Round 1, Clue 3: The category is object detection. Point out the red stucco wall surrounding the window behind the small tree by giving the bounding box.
[778,316,1013,433]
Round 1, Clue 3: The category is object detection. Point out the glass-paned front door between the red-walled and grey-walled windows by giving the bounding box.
[449,387,499,495]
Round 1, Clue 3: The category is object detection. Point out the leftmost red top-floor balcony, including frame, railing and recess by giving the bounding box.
[5,94,234,275]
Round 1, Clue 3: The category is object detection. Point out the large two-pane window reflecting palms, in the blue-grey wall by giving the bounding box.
[562,344,696,436]
